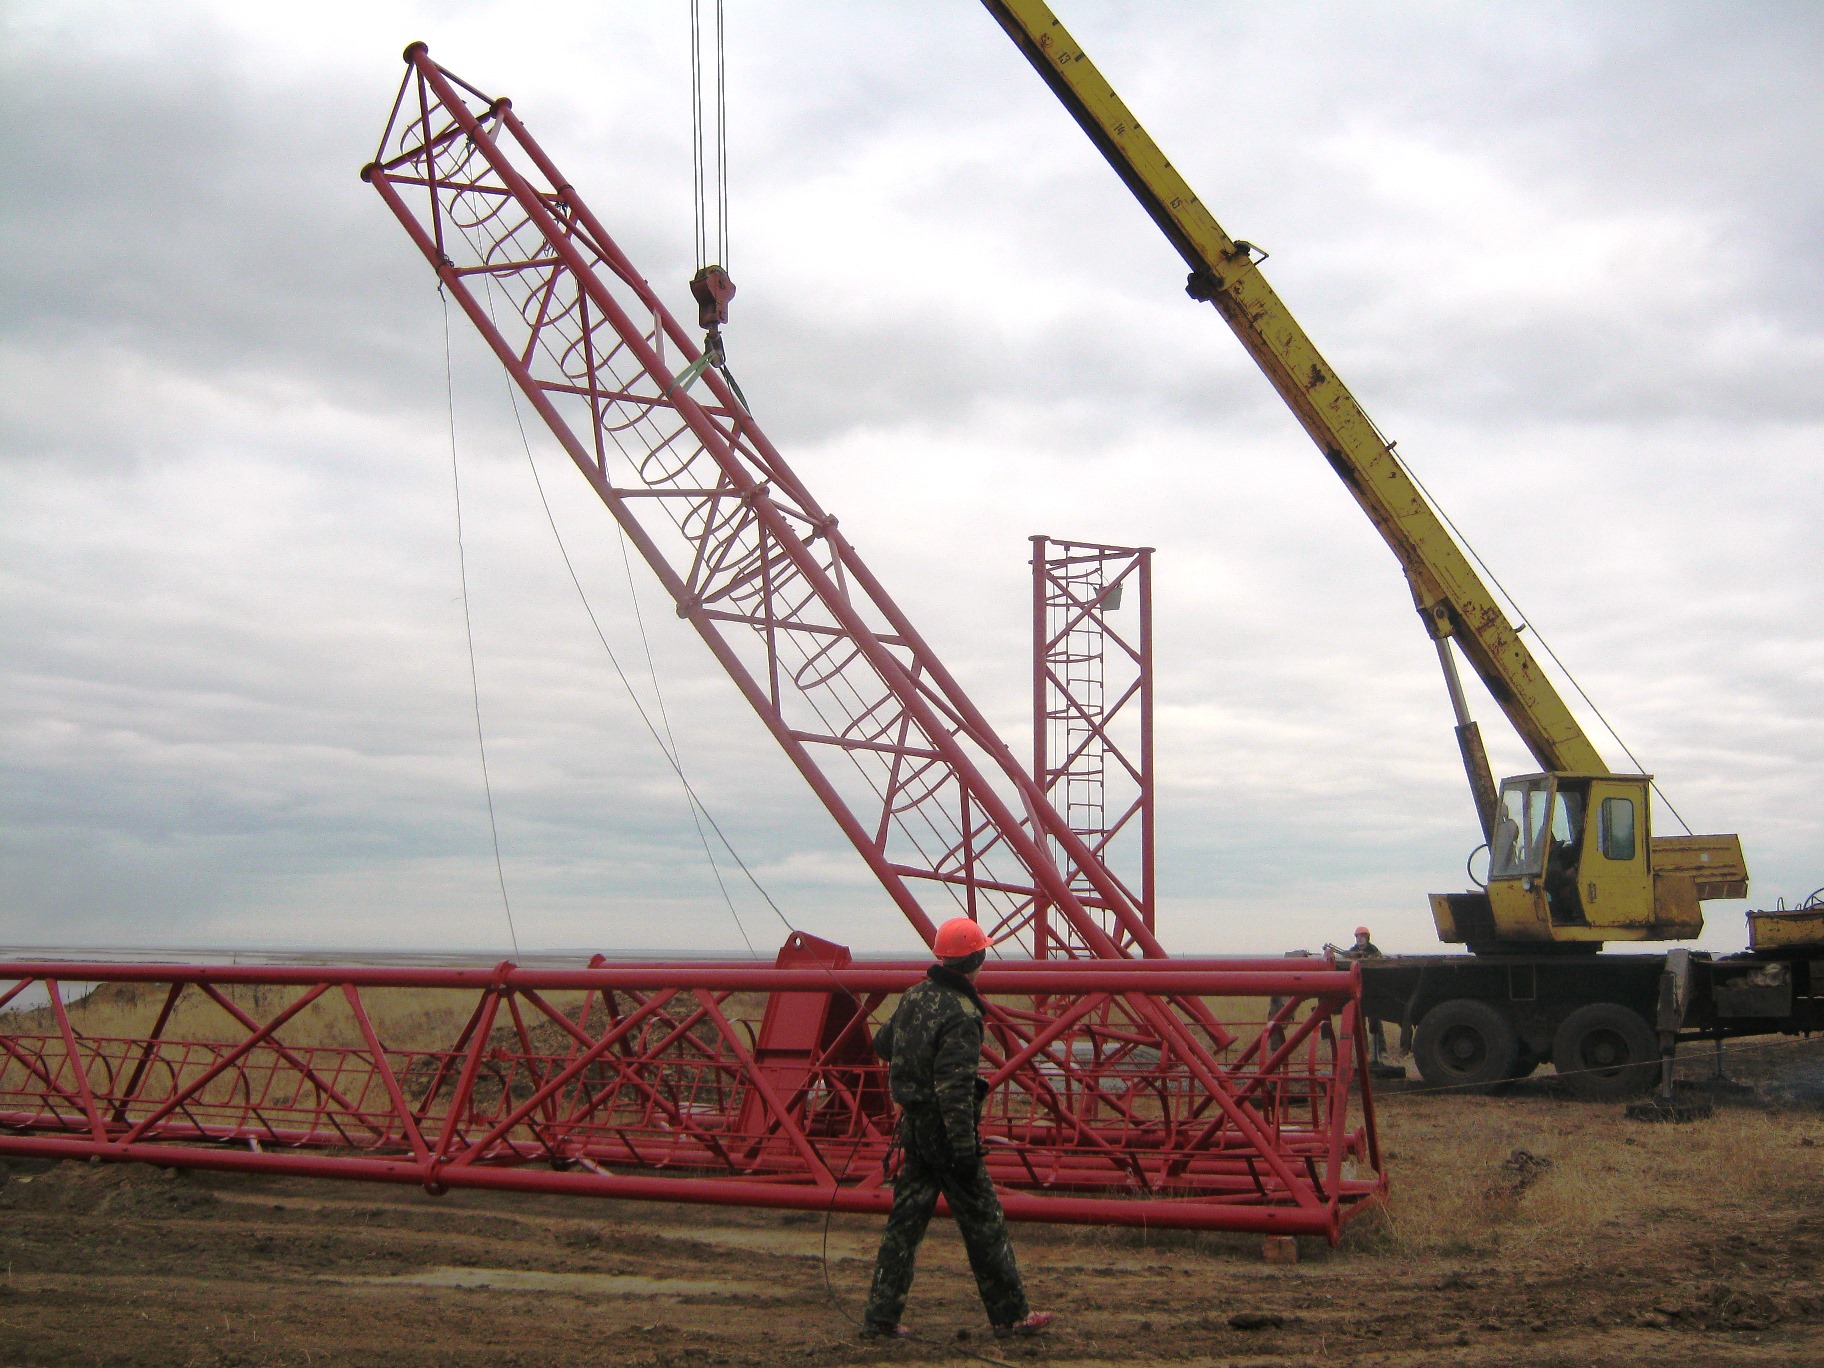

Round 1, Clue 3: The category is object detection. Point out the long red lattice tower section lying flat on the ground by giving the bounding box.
[0,936,1384,1240]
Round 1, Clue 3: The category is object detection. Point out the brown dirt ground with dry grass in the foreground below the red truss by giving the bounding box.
[0,1042,1824,1364]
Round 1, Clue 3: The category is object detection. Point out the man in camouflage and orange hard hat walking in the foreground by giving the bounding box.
[861,917,1052,1339]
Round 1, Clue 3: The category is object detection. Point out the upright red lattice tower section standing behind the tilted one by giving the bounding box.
[1032,536,1153,948]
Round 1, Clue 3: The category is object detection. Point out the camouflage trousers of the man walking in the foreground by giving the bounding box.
[866,1113,1031,1326]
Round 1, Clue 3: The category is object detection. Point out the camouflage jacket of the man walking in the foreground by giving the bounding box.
[874,965,981,1160]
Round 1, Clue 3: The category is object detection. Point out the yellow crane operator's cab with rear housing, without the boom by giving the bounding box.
[1432,773,1747,950]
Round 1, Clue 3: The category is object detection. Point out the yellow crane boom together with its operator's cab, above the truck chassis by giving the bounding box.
[983,0,1747,952]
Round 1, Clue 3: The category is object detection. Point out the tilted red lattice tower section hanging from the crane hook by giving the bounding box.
[363,44,1164,956]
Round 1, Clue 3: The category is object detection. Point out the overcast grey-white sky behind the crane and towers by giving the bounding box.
[0,0,1824,954]
